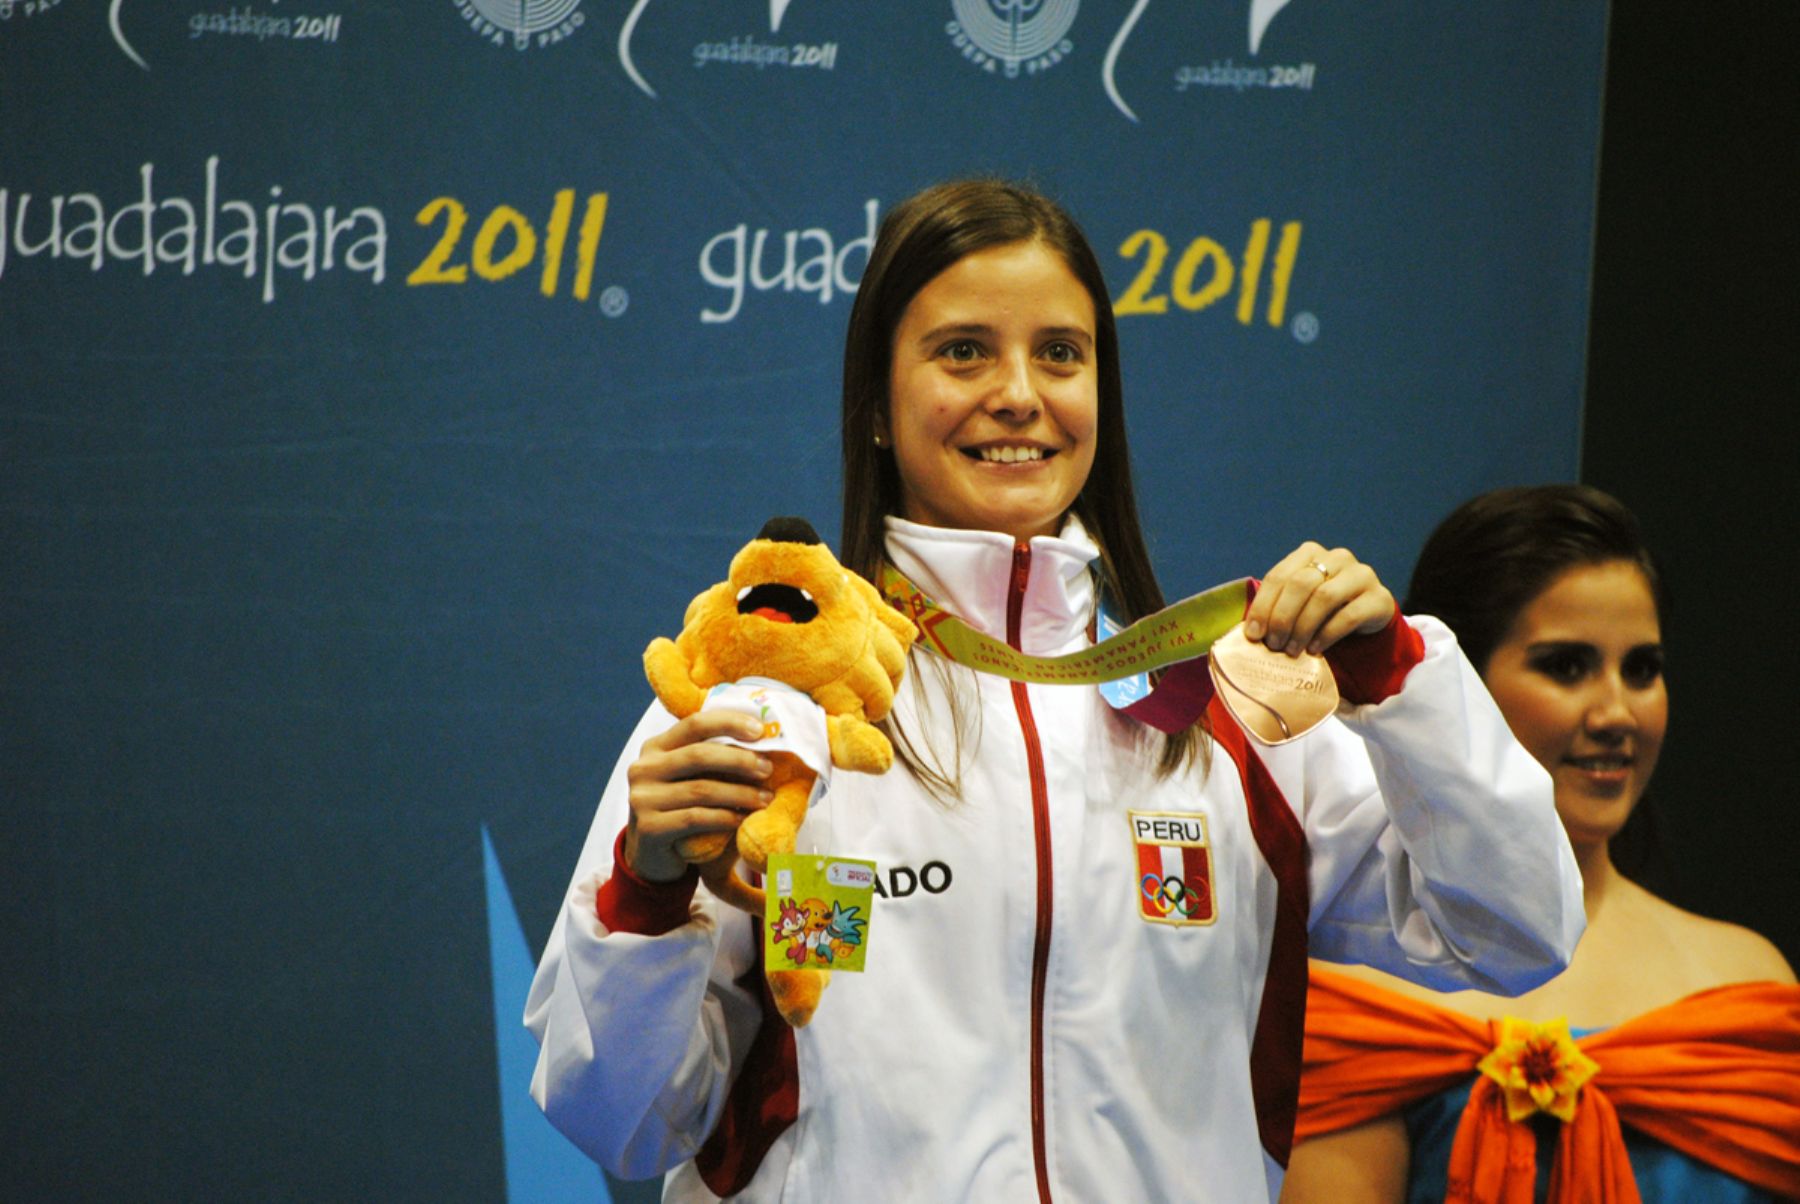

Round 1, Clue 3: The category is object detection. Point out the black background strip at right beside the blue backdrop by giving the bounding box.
[1582,0,1800,963]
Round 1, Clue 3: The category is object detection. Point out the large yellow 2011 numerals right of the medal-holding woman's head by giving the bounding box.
[1112,218,1300,326]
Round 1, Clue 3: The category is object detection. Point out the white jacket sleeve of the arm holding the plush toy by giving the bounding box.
[526,707,761,1179]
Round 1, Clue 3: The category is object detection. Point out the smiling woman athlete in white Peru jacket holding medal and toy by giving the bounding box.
[526,180,1582,1200]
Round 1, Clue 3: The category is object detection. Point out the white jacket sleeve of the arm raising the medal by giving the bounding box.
[1264,615,1586,995]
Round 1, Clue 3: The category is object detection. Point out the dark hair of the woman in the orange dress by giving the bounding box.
[1400,484,1669,891]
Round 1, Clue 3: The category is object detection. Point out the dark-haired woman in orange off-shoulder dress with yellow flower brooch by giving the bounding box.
[1282,486,1800,1204]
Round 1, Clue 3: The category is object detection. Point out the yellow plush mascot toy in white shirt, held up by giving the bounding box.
[644,518,916,1028]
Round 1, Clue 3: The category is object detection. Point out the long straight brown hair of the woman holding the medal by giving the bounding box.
[841,180,1195,786]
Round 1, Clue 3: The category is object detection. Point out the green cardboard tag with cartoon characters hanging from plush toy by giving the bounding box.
[763,853,875,970]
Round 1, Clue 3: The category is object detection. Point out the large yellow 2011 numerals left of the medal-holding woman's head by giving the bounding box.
[407,189,607,301]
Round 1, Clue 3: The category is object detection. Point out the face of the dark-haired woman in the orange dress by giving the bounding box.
[1481,560,1669,844]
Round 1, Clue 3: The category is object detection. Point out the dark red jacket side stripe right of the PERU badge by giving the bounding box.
[1210,700,1312,1166]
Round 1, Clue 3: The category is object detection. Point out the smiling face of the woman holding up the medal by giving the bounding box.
[882,241,1100,542]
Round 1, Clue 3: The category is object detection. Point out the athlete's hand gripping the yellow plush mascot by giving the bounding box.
[625,711,774,882]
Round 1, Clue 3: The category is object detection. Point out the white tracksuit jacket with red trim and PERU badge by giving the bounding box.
[526,520,1584,1204]
